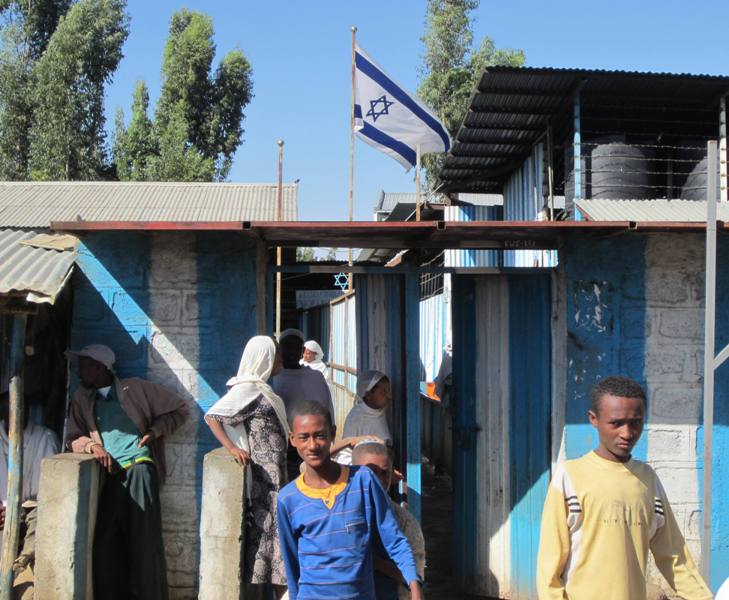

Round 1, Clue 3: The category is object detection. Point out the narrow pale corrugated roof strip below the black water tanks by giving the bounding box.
[577,199,729,223]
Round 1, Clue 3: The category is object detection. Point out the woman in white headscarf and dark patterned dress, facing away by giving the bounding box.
[205,335,289,598]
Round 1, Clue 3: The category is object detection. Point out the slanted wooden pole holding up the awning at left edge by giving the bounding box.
[0,314,28,600]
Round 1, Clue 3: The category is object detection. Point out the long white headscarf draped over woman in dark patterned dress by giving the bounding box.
[206,335,289,452]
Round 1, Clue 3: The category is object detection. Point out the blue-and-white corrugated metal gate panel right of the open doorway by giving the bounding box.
[453,275,551,600]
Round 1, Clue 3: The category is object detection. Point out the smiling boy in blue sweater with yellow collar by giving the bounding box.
[277,402,423,600]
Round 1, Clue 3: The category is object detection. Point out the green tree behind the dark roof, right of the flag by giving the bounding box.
[418,0,525,187]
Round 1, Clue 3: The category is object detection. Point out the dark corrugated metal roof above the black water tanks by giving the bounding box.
[440,67,729,192]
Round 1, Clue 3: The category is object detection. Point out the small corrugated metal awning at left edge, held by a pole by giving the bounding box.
[0,229,76,304]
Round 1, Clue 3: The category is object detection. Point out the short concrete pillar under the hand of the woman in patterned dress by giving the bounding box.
[198,448,246,600]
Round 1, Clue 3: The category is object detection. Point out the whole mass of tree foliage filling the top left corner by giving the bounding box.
[0,0,128,180]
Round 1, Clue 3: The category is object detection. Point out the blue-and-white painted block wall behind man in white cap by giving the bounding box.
[72,232,256,599]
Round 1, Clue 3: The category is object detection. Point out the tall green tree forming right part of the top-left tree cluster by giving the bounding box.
[29,0,129,180]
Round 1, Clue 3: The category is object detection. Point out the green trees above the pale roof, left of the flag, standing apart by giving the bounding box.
[114,9,252,181]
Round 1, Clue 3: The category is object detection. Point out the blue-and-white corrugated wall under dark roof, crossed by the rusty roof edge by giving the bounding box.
[504,144,557,267]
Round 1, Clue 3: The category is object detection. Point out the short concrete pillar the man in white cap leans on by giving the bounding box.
[35,453,101,600]
